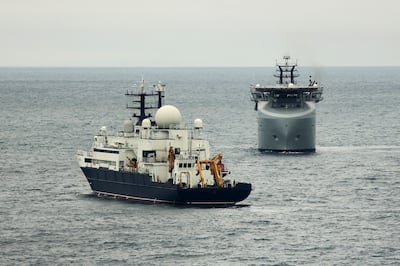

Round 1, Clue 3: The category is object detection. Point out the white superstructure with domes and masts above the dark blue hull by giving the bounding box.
[78,80,231,188]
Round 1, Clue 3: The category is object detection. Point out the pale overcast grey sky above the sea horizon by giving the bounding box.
[0,0,400,67]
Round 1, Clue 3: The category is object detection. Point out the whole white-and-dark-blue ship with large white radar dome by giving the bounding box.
[78,81,252,206]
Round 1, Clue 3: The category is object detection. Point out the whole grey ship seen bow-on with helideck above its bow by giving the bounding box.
[250,56,323,152]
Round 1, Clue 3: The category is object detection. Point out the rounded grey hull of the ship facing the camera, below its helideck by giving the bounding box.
[257,102,316,152]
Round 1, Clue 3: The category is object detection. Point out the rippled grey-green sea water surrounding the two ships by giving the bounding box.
[0,67,400,265]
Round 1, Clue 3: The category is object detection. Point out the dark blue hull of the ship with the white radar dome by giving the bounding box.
[81,167,251,206]
